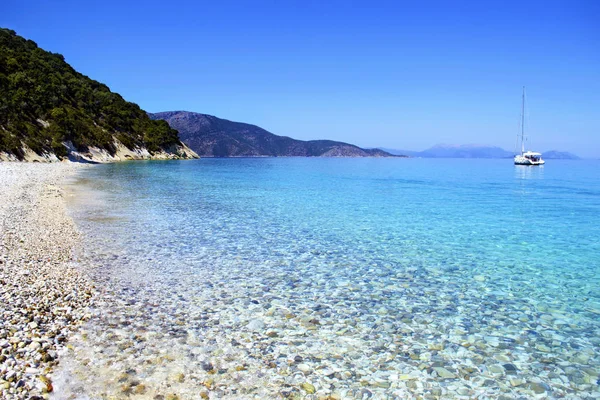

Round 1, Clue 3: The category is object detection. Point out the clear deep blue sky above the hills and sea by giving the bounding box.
[0,0,600,157]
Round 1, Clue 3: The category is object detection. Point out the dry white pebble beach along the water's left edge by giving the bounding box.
[0,162,95,399]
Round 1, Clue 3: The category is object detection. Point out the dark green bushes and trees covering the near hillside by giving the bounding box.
[0,28,179,158]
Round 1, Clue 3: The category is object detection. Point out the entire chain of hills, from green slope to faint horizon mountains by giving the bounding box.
[0,28,579,162]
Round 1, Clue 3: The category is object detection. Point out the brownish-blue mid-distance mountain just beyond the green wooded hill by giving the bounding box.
[148,111,392,157]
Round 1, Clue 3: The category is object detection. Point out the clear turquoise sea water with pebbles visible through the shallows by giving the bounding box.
[57,158,600,398]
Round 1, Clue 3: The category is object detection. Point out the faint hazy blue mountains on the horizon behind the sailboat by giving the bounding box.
[382,144,579,160]
